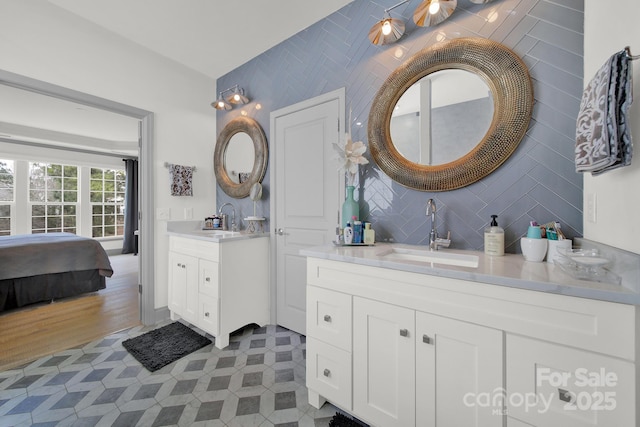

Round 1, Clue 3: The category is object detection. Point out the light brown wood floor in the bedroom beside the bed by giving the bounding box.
[0,255,140,371]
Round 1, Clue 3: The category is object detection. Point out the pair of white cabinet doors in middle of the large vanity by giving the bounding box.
[353,297,503,427]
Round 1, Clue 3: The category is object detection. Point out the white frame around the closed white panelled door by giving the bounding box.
[269,87,346,325]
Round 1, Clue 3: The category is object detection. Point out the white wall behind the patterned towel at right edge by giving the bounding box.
[583,0,640,253]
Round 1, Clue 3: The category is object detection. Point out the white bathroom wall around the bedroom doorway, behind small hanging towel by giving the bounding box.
[0,0,216,308]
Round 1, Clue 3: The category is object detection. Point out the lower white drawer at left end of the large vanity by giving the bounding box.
[307,337,351,411]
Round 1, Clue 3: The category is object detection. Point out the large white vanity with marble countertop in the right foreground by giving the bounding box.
[302,244,640,427]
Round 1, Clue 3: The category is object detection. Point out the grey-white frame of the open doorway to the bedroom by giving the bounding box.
[0,70,156,325]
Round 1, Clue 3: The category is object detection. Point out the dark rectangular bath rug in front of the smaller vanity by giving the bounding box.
[122,322,211,372]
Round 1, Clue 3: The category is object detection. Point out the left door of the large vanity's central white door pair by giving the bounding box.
[353,297,416,427]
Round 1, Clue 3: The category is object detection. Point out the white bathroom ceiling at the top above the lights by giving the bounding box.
[49,0,353,79]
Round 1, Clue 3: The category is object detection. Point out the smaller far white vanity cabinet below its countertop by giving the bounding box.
[169,235,269,348]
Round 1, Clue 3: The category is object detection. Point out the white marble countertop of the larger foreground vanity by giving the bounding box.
[300,243,640,305]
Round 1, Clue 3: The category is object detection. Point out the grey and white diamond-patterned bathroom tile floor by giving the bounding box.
[0,324,336,427]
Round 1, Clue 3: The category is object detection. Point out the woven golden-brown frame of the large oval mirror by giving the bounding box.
[368,38,533,191]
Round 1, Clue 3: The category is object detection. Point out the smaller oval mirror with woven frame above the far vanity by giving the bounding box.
[213,117,269,199]
